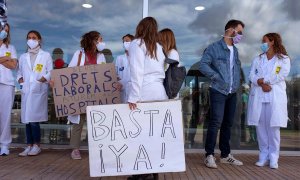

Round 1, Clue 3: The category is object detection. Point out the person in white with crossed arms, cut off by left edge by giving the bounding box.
[0,24,17,156]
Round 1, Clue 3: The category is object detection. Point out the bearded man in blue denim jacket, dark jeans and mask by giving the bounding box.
[199,20,245,168]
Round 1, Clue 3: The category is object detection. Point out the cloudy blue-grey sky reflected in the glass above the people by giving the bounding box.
[8,0,300,74]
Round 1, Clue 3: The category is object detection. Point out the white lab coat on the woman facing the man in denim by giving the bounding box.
[247,54,290,127]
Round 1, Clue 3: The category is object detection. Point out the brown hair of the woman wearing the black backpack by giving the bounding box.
[158,28,177,54]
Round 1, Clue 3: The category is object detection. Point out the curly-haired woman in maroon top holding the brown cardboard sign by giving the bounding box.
[68,31,106,159]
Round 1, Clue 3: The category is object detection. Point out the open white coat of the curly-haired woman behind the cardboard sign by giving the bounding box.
[68,50,106,124]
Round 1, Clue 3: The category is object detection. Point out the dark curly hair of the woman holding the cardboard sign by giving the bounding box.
[80,31,101,52]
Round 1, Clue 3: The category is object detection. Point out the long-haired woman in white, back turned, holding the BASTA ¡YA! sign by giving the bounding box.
[128,17,168,179]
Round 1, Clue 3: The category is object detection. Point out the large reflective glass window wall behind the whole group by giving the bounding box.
[8,0,300,150]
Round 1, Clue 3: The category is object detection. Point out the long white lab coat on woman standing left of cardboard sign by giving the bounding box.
[17,49,53,123]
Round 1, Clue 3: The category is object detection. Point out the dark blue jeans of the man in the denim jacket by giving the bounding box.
[205,88,236,158]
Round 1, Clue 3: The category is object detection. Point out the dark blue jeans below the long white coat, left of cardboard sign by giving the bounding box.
[26,122,41,144]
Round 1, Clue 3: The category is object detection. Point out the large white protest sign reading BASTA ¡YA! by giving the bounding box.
[87,100,185,177]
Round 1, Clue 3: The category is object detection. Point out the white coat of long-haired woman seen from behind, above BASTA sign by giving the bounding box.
[128,39,168,103]
